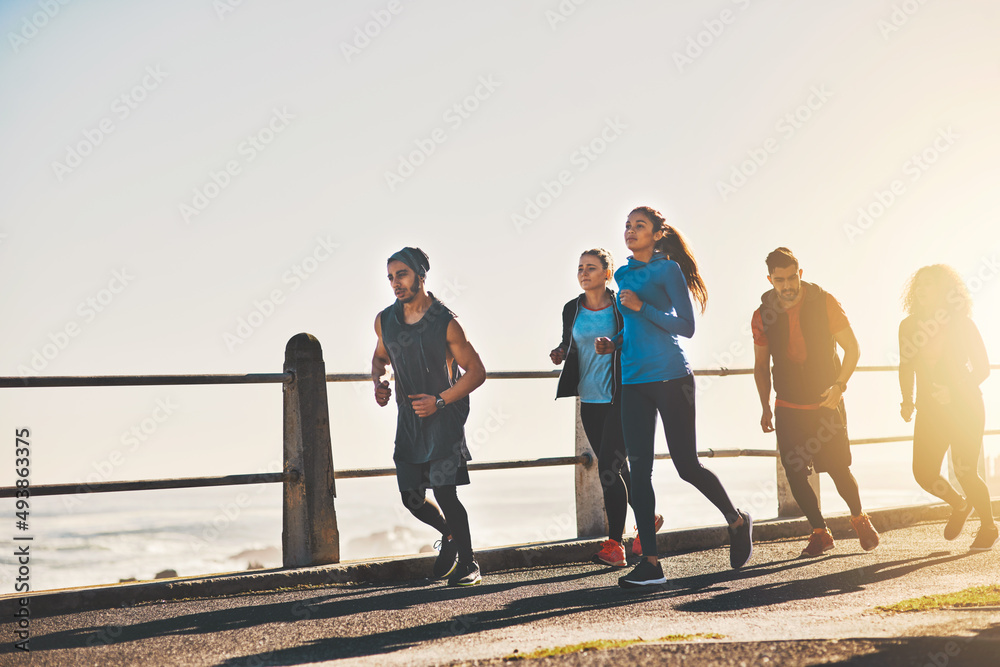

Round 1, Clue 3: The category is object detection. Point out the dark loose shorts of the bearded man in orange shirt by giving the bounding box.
[774,402,851,474]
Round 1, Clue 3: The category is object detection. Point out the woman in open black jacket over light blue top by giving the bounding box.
[549,248,648,567]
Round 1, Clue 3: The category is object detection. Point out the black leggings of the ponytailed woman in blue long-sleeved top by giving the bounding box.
[622,375,739,556]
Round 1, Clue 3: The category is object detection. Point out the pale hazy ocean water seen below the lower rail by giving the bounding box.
[0,438,1000,593]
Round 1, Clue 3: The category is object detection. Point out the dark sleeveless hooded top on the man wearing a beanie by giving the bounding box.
[379,294,472,463]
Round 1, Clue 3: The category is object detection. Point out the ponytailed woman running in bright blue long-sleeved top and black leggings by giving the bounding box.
[596,206,753,588]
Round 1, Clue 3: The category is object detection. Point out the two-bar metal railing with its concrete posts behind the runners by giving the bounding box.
[0,333,1000,567]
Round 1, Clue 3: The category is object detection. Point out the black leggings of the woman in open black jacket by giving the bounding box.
[580,399,631,543]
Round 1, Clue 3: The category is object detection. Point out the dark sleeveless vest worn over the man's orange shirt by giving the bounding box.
[760,282,840,405]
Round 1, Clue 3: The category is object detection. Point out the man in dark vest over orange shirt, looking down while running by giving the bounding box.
[751,248,879,556]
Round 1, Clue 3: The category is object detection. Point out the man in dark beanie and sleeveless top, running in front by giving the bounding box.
[372,248,486,586]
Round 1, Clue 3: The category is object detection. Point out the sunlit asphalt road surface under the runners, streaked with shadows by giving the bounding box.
[0,521,1000,667]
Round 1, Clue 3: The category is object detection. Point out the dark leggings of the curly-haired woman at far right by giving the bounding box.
[913,396,993,524]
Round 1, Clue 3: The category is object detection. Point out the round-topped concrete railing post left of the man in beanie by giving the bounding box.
[281,333,340,567]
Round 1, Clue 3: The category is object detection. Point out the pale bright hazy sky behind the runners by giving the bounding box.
[0,0,1000,483]
